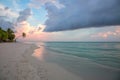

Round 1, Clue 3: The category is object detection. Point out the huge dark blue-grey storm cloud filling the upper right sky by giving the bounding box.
[40,0,120,32]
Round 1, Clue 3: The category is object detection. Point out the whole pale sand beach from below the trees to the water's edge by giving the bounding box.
[0,43,82,80]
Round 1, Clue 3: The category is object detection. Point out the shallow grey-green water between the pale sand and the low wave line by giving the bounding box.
[38,43,120,80]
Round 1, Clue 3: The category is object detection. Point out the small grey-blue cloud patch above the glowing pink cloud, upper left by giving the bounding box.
[17,8,32,22]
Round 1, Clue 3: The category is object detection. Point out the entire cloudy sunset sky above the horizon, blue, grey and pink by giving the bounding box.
[0,0,120,41]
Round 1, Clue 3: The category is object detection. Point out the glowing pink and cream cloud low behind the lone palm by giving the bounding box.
[15,21,47,41]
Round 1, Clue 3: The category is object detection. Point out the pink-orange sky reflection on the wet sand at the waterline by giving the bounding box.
[32,47,44,60]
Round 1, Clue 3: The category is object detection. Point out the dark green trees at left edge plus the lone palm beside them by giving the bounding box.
[0,27,26,42]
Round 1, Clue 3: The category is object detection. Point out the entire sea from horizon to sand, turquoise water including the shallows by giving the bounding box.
[34,42,120,80]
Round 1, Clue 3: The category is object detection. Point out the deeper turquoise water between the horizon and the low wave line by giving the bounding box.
[45,42,120,69]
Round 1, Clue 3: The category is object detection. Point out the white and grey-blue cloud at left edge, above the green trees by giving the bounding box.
[0,4,19,29]
